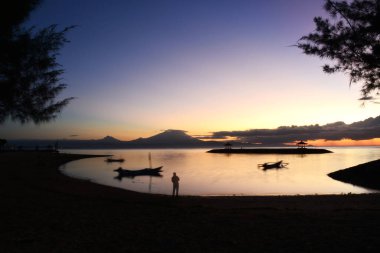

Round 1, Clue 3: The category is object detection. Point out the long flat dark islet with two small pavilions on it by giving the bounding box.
[207,148,332,155]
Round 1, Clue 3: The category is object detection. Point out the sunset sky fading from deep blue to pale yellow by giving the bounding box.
[0,0,380,144]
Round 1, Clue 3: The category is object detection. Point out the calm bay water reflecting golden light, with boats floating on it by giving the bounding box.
[61,147,380,196]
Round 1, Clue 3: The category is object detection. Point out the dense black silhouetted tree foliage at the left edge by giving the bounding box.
[0,0,72,123]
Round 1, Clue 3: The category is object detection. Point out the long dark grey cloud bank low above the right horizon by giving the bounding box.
[211,116,380,145]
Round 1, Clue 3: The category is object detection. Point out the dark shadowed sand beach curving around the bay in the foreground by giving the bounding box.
[0,152,380,252]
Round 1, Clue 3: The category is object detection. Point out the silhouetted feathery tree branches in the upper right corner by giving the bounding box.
[297,0,380,100]
